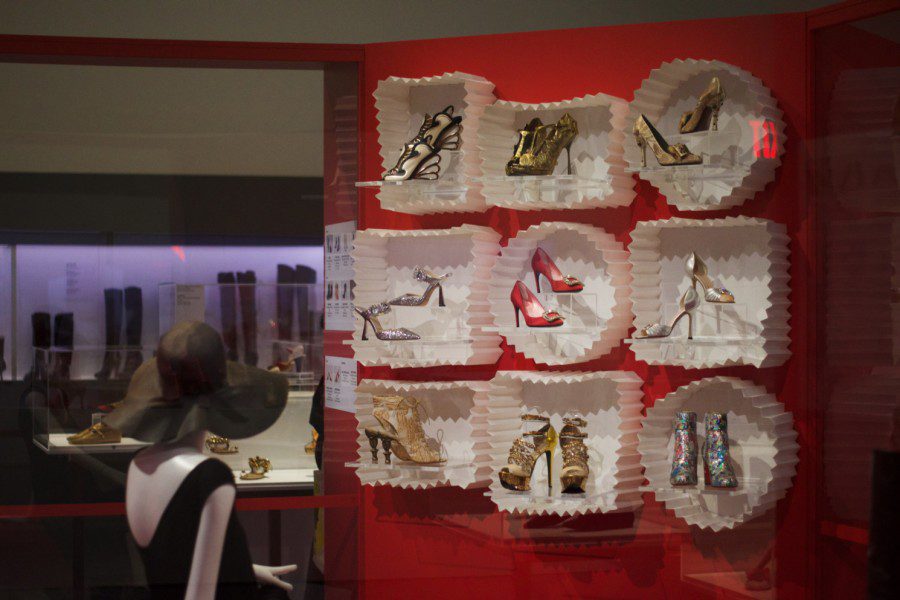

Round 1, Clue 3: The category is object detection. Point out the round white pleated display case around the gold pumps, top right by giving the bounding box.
[625,59,786,210]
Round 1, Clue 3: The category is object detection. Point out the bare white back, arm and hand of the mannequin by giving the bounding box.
[125,431,297,600]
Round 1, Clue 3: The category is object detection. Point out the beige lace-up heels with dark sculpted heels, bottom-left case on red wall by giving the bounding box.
[365,396,447,465]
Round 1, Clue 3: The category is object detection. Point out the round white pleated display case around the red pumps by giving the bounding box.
[489,222,632,365]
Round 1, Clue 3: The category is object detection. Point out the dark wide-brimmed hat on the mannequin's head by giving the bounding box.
[103,322,288,443]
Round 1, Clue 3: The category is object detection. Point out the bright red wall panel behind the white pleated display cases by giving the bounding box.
[344,11,814,600]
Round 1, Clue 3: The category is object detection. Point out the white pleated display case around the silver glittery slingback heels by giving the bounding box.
[345,225,501,368]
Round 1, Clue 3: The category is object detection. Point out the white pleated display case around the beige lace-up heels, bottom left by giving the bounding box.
[348,379,491,489]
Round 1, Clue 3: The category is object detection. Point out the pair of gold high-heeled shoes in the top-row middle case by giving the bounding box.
[506,113,578,175]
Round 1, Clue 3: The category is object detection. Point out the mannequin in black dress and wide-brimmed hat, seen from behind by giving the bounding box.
[105,322,297,600]
